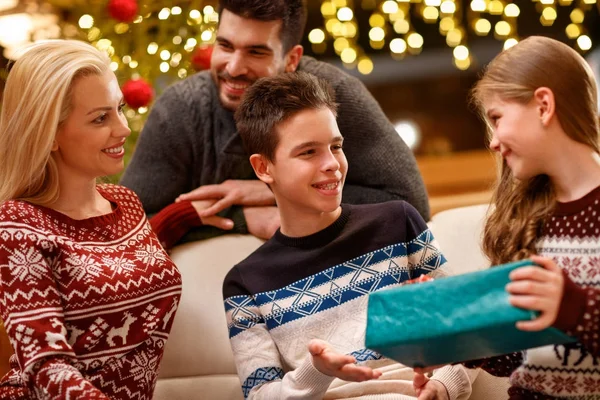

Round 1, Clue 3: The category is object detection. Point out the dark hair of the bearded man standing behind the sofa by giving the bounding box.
[219,0,306,53]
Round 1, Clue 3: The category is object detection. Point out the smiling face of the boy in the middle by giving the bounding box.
[267,108,348,238]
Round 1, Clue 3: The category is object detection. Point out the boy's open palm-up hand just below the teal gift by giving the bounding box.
[308,339,381,382]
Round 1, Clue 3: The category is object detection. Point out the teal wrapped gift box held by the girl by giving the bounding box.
[365,260,575,367]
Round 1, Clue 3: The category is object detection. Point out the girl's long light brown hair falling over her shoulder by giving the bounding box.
[472,36,600,265]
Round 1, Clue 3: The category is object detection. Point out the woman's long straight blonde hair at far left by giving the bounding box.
[0,40,110,204]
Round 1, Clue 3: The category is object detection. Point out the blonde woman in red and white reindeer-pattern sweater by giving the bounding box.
[0,41,181,400]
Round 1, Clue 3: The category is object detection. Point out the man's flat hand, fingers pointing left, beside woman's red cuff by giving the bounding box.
[175,179,275,218]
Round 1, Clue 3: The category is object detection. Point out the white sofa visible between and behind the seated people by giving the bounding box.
[154,206,508,400]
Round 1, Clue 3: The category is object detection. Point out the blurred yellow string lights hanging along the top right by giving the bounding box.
[308,0,600,74]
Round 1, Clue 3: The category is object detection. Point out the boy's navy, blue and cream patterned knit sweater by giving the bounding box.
[223,201,471,400]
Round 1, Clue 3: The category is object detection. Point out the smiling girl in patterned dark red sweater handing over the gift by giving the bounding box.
[415,36,600,400]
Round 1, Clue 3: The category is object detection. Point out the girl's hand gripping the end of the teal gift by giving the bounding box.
[506,256,564,331]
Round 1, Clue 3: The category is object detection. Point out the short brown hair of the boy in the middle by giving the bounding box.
[235,72,337,162]
